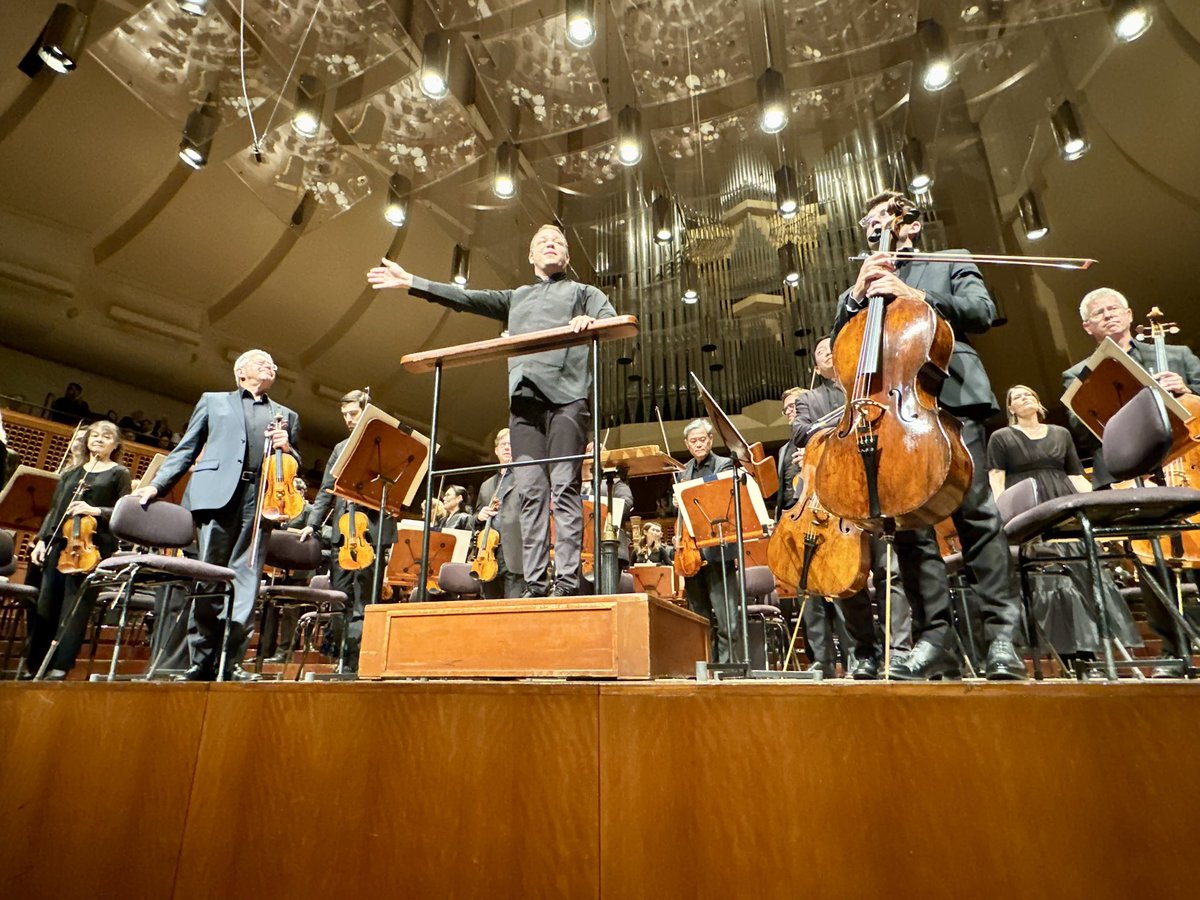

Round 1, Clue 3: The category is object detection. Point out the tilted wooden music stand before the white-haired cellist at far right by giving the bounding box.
[1062,337,1196,462]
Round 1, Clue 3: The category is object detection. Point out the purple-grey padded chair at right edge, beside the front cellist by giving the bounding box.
[1004,388,1200,680]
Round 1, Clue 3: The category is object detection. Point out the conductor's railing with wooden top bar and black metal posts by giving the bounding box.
[400,316,637,593]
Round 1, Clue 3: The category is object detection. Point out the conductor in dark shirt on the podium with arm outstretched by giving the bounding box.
[367,224,617,596]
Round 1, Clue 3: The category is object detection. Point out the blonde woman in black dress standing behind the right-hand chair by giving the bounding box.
[988,384,1141,659]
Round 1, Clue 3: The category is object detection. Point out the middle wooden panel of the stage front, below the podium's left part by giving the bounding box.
[175,684,600,900]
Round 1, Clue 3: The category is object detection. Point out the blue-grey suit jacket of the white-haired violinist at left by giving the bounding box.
[152,389,300,512]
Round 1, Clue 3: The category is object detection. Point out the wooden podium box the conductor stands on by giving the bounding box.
[359,594,709,678]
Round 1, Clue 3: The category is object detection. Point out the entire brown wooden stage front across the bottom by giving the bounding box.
[0,682,1200,900]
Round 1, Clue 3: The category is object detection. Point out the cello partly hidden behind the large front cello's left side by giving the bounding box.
[767,427,871,599]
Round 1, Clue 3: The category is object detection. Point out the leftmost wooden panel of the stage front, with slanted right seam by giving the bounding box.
[0,683,206,900]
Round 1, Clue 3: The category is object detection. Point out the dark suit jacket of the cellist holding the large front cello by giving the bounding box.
[833,250,1000,420]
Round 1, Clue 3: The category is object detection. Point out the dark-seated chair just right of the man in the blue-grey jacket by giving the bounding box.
[254,529,349,682]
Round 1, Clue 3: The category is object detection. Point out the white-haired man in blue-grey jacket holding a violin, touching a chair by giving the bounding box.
[133,350,300,682]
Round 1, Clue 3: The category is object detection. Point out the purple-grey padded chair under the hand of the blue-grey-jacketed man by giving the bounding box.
[37,497,234,682]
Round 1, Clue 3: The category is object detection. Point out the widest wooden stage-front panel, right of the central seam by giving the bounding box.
[600,684,1200,900]
